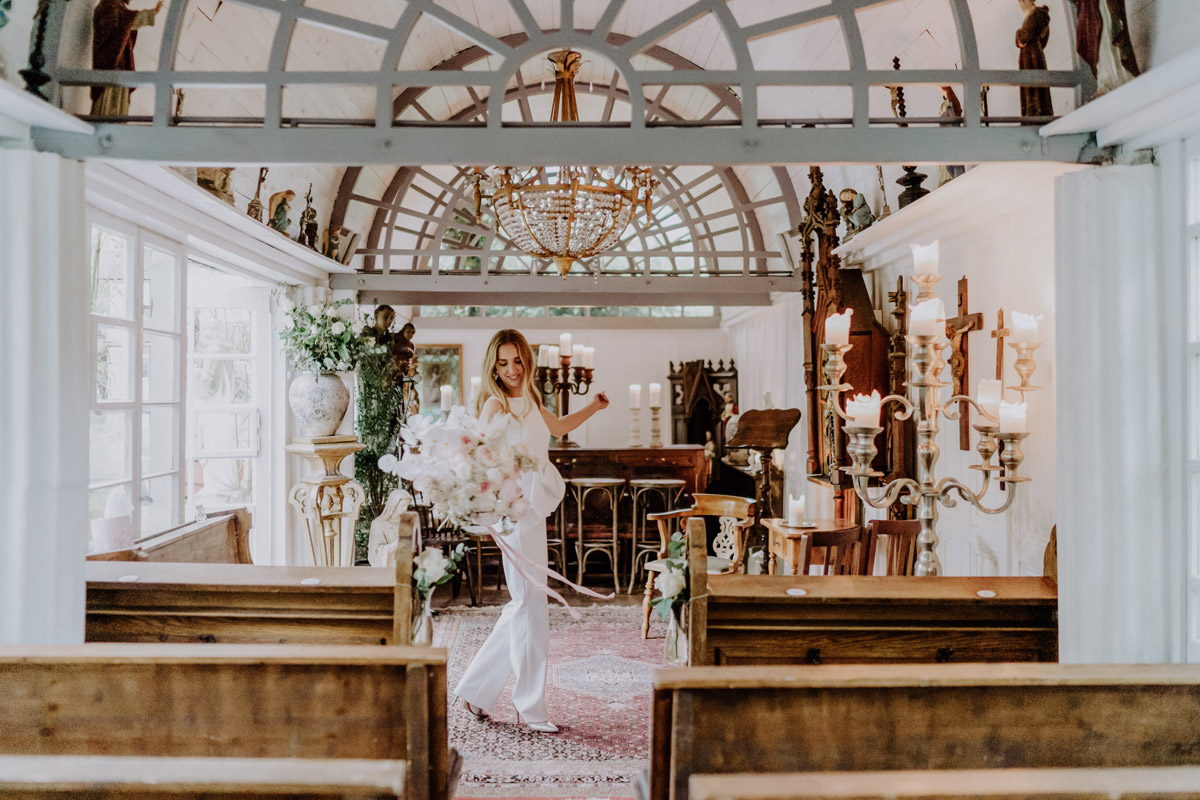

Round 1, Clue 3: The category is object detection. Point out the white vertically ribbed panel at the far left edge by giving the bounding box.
[0,150,91,644]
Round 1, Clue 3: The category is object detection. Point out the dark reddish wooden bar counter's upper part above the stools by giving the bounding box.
[550,445,707,494]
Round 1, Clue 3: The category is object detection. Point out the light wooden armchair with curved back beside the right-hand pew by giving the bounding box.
[642,493,755,639]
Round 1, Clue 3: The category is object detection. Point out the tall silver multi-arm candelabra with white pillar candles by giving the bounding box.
[817,273,1039,576]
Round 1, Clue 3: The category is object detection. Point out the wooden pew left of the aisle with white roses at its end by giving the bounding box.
[84,513,415,644]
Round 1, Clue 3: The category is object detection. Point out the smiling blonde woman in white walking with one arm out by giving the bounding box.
[455,329,608,733]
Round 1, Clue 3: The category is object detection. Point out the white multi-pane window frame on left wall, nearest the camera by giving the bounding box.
[86,206,187,541]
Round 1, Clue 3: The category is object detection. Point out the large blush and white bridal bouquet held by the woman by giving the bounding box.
[379,405,538,528]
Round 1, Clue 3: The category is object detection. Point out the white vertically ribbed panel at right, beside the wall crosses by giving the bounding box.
[1056,166,1187,663]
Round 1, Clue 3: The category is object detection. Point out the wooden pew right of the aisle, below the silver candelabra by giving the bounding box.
[688,527,1058,666]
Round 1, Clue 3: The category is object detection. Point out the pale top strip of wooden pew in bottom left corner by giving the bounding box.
[0,756,404,800]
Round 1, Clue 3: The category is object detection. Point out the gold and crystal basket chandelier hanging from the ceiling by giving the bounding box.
[474,50,658,278]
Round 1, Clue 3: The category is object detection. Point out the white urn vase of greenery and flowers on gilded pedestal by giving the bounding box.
[280,296,382,437]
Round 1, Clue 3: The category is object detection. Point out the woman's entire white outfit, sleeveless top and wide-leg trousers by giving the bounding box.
[455,397,566,722]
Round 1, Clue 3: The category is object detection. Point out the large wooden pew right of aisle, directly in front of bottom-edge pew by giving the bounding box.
[646,663,1200,800]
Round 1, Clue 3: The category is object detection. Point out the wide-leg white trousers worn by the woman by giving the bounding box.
[455,515,550,722]
